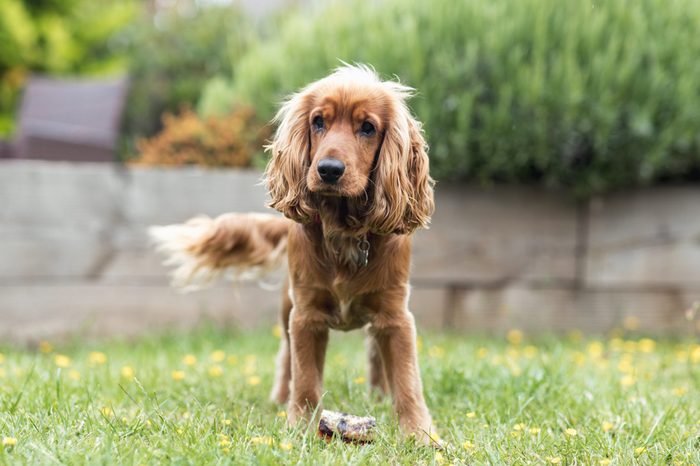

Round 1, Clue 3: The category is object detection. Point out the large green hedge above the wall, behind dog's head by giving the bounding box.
[215,0,700,195]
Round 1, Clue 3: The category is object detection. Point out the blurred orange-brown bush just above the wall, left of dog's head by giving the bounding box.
[131,108,269,167]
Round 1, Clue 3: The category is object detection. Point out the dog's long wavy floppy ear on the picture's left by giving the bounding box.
[264,91,312,223]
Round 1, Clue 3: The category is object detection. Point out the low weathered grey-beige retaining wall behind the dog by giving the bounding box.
[0,161,700,339]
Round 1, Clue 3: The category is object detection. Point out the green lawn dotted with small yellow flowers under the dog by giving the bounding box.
[0,327,700,465]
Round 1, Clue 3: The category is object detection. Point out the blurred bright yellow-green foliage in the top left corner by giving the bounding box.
[0,0,137,136]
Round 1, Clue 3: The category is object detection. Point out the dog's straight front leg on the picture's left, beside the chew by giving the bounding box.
[287,305,328,425]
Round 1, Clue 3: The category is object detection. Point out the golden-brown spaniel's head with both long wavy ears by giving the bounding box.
[265,66,434,234]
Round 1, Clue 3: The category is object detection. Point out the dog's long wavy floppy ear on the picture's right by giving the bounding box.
[368,97,435,234]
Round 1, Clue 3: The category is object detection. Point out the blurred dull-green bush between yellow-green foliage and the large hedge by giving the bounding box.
[123,4,253,151]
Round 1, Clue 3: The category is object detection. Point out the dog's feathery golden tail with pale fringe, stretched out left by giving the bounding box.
[148,213,291,291]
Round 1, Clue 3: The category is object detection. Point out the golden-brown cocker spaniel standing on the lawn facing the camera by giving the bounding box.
[150,65,435,444]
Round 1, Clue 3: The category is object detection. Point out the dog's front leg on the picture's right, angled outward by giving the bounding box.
[369,309,435,444]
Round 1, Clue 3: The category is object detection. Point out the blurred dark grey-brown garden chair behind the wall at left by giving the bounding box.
[0,76,128,162]
